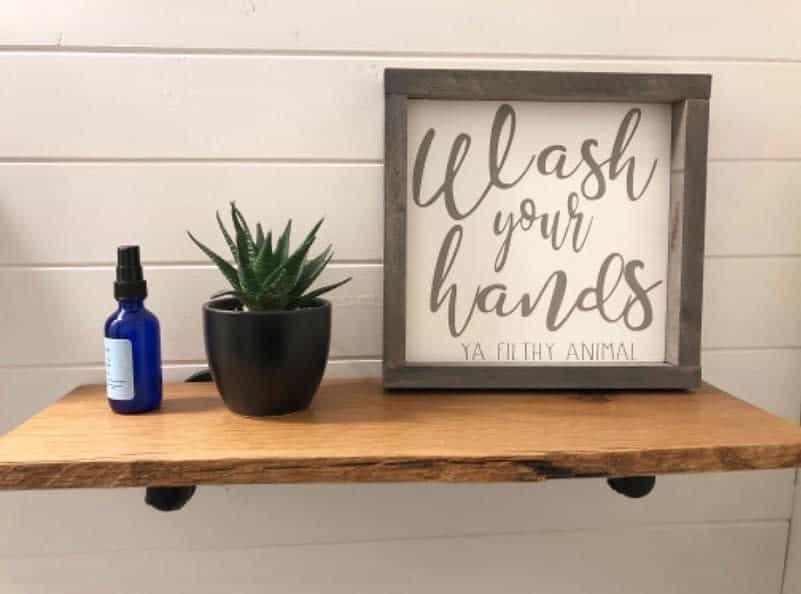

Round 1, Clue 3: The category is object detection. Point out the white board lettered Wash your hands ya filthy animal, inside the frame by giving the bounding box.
[405,99,671,365]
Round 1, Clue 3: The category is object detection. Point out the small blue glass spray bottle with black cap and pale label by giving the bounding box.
[104,246,162,414]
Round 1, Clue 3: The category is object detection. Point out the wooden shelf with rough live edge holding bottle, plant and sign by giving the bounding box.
[0,380,801,489]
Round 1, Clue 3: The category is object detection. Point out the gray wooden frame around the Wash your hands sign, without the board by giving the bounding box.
[383,69,711,389]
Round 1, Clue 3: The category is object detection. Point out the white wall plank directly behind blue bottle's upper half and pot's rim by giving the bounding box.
[0,257,801,366]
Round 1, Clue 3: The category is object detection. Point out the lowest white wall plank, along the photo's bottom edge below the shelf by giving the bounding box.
[0,520,787,594]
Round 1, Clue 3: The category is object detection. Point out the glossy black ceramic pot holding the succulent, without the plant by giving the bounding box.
[203,299,331,417]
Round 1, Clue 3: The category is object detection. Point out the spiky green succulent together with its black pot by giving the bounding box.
[187,202,350,416]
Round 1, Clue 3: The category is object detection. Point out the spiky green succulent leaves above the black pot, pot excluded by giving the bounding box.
[187,202,350,311]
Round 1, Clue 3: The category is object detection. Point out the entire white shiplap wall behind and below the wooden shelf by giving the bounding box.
[0,0,801,594]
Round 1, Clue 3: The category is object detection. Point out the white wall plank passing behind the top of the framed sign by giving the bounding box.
[0,54,801,160]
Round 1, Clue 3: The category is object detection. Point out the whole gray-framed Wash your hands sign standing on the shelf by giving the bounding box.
[384,70,711,389]
